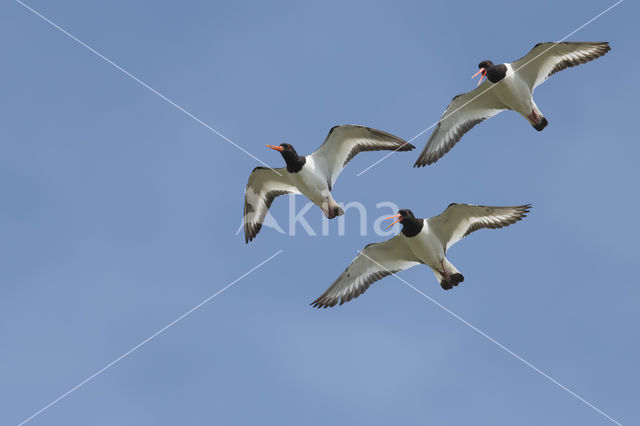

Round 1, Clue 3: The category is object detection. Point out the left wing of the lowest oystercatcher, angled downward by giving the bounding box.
[311,234,420,308]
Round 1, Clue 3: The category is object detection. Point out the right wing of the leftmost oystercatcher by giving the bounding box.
[311,124,415,189]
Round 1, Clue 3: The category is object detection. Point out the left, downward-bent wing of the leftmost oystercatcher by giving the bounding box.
[244,167,300,243]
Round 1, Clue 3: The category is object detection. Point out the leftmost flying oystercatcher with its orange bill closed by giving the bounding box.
[243,124,415,243]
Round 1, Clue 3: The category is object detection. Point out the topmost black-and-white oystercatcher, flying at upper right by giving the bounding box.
[413,42,611,167]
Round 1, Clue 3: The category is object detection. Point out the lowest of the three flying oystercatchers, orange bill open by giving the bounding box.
[311,203,531,308]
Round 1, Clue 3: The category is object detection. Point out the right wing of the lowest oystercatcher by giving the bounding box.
[428,203,531,251]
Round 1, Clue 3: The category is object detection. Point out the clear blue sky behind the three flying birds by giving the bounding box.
[0,0,640,426]
